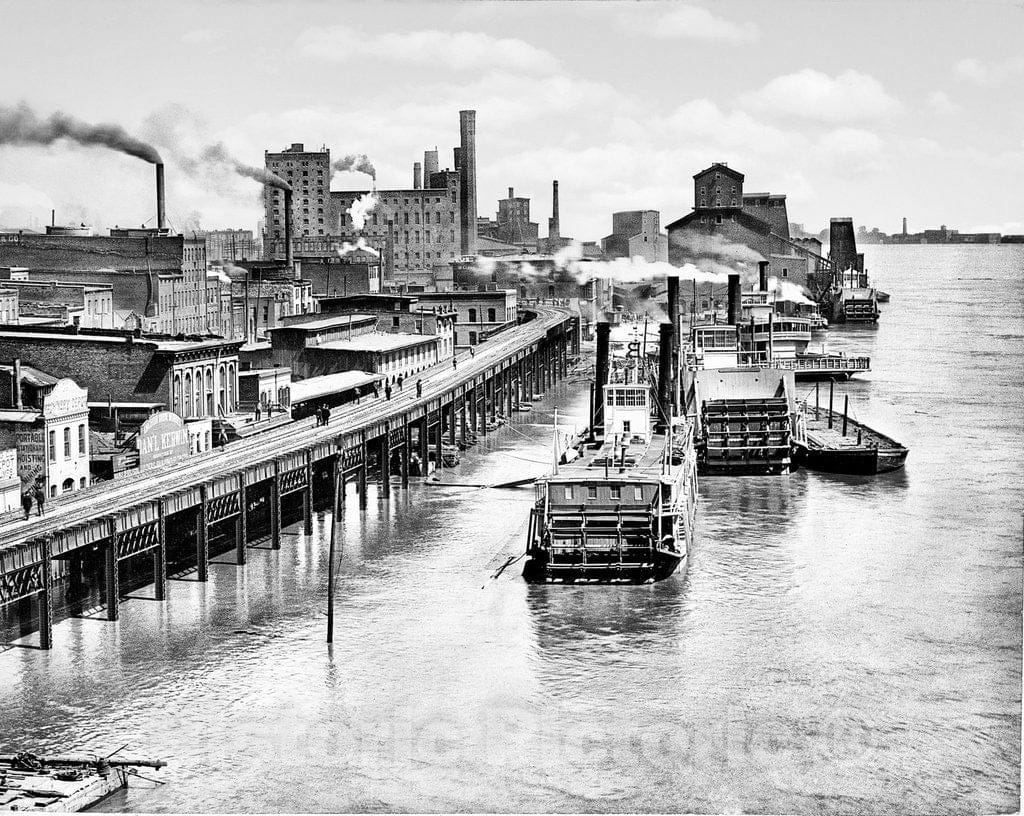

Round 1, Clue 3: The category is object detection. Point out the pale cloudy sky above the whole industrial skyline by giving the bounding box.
[0,0,1024,240]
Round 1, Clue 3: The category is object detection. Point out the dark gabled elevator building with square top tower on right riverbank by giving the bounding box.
[667,162,834,293]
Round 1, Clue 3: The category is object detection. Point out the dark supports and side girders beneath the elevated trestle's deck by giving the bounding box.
[0,321,580,649]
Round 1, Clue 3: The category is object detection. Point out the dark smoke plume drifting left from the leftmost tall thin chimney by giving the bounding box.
[0,102,161,164]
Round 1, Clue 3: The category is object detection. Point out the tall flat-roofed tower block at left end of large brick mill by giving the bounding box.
[263,142,331,248]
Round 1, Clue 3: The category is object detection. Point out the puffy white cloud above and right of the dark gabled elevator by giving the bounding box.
[740,69,900,122]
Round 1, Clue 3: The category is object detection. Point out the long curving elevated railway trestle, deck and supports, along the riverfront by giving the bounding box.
[0,306,581,649]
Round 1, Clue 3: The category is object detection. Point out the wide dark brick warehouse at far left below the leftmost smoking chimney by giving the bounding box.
[0,229,207,335]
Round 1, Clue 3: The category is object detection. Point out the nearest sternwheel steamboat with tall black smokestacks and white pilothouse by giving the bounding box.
[522,324,697,584]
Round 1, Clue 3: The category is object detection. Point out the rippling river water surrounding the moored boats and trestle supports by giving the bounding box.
[0,246,1024,814]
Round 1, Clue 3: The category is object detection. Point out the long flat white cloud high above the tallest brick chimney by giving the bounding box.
[296,26,559,74]
